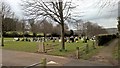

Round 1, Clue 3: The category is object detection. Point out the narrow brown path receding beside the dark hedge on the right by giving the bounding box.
[90,39,118,65]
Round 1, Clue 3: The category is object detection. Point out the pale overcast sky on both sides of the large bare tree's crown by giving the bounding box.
[5,0,120,28]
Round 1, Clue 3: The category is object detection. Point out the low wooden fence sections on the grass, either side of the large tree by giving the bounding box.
[39,41,96,59]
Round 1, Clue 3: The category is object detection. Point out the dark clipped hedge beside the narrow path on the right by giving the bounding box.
[97,34,117,46]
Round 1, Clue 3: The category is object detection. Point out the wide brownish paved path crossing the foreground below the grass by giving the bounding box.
[2,50,109,66]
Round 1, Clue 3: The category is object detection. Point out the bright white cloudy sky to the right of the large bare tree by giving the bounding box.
[73,0,119,28]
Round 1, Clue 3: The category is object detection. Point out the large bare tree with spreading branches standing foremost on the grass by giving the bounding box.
[23,0,76,50]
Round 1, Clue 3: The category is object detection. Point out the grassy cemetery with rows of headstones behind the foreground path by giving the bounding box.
[3,34,100,58]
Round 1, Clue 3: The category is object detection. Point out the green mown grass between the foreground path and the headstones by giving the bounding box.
[3,38,101,59]
